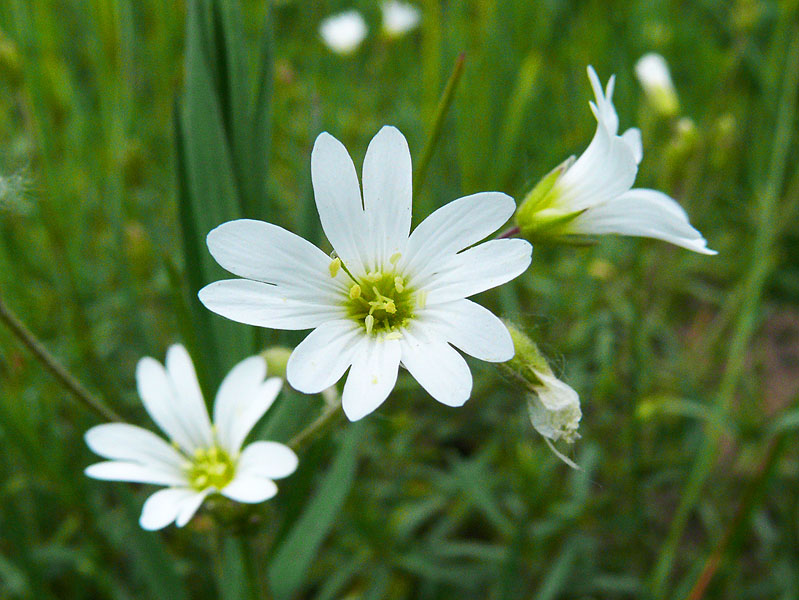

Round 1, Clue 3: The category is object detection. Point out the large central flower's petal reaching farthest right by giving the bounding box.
[426,239,533,306]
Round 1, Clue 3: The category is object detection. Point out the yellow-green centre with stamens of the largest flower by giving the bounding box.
[347,271,418,338]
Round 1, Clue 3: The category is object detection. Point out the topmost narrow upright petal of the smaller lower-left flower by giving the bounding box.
[166,344,213,447]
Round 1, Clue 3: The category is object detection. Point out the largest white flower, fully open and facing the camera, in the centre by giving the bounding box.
[200,127,532,421]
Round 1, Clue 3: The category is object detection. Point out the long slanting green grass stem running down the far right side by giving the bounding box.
[651,27,799,600]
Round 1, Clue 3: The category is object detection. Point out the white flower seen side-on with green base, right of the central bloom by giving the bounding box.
[516,67,716,254]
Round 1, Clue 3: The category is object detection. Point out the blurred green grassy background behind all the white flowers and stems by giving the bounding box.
[0,0,799,600]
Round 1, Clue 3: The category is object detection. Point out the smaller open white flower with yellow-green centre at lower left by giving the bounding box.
[86,345,297,530]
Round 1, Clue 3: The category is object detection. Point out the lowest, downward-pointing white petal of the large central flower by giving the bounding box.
[341,337,402,421]
